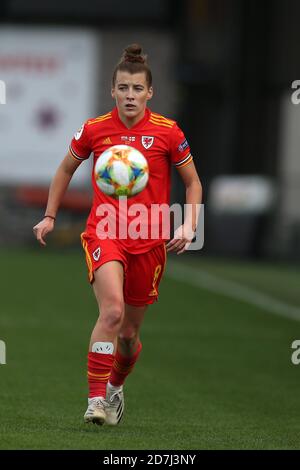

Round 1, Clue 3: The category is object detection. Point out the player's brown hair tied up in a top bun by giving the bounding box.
[112,44,152,88]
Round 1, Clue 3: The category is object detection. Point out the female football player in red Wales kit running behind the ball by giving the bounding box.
[33,44,202,425]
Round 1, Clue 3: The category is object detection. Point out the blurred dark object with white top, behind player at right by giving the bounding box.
[206,175,275,256]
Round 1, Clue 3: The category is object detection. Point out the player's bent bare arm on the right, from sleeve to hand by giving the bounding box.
[166,161,202,255]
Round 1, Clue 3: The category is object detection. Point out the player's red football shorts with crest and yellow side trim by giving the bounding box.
[81,232,167,307]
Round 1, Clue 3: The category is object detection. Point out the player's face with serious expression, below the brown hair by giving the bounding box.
[111,70,153,124]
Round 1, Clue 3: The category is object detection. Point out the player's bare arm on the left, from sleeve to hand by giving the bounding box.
[33,151,82,246]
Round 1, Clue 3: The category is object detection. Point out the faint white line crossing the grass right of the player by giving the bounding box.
[166,261,300,321]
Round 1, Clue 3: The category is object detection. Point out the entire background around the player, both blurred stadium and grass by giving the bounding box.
[0,0,300,449]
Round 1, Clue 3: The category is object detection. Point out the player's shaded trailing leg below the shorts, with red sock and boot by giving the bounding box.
[106,304,148,425]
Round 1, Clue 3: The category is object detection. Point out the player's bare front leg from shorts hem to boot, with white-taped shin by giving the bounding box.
[84,261,124,424]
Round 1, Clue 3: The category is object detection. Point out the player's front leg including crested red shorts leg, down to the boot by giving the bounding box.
[81,232,127,424]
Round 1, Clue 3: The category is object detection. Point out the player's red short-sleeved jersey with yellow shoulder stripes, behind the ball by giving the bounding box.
[70,108,192,253]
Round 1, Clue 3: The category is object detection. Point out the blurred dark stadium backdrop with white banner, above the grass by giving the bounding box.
[0,0,300,260]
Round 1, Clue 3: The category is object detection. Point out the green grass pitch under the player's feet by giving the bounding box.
[0,248,300,450]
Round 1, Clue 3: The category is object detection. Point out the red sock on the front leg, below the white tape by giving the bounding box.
[87,352,114,398]
